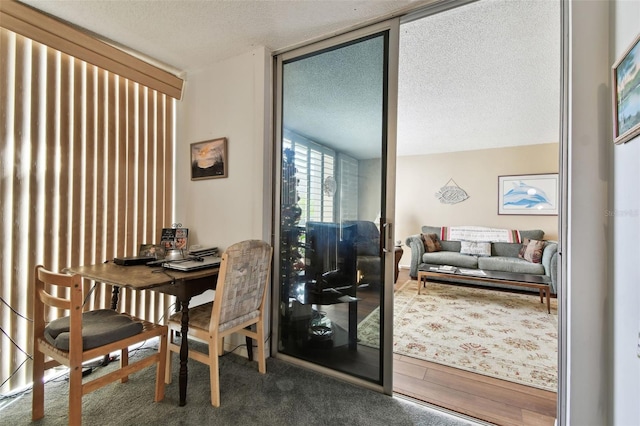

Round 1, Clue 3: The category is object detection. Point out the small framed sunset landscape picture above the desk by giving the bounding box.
[191,138,229,180]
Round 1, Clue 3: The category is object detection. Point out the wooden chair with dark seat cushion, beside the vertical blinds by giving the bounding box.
[31,265,167,425]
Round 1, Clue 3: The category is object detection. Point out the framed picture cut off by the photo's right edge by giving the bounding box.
[611,34,640,144]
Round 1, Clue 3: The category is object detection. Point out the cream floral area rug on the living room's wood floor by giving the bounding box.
[358,280,558,392]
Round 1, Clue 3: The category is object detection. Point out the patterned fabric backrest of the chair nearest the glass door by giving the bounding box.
[210,240,273,331]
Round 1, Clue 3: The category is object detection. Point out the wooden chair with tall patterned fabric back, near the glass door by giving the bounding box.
[165,240,273,407]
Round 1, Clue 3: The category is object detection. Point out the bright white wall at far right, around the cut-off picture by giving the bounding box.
[606,1,640,425]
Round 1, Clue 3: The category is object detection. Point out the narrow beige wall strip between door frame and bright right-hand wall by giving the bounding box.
[563,1,611,426]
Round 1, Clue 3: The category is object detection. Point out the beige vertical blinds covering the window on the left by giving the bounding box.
[0,28,176,394]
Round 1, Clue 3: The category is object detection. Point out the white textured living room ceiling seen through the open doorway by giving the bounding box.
[398,0,561,155]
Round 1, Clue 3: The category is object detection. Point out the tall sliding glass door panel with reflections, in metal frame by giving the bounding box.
[274,21,398,393]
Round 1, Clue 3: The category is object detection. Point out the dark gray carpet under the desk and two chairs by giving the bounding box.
[0,342,474,426]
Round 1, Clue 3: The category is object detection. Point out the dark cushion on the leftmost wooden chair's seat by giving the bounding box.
[44,309,142,351]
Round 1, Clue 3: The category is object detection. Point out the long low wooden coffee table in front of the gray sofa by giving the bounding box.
[418,263,551,313]
